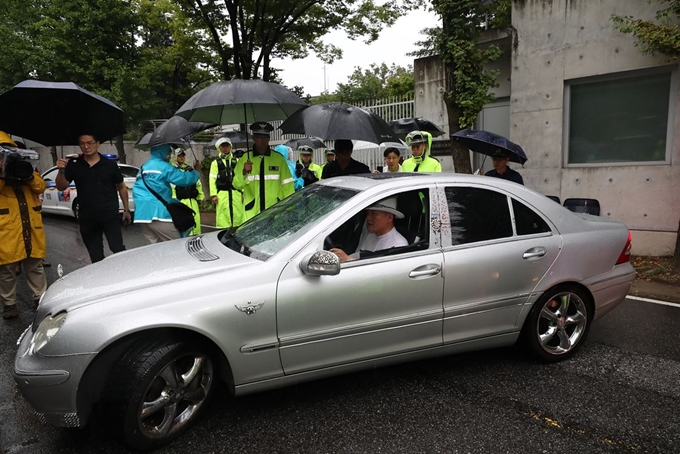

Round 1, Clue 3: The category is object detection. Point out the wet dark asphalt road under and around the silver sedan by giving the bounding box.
[0,216,680,454]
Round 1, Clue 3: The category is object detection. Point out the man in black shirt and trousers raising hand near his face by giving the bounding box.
[55,134,131,263]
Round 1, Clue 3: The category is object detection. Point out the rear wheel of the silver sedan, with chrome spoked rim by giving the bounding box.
[522,285,593,363]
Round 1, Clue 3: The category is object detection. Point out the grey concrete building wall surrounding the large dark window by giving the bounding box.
[414,0,680,255]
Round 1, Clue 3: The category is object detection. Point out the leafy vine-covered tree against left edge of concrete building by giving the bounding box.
[414,0,511,173]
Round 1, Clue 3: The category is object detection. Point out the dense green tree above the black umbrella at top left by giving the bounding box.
[0,0,218,152]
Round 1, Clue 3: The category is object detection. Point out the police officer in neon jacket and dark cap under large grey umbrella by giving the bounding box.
[234,122,295,220]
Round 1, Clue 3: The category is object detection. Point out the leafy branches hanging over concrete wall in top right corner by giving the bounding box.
[612,0,680,268]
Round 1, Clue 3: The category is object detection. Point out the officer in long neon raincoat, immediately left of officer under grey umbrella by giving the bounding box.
[208,137,245,229]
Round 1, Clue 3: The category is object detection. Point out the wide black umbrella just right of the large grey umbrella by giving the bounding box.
[279,102,399,143]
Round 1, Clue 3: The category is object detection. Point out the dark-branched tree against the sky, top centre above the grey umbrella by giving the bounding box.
[178,0,423,81]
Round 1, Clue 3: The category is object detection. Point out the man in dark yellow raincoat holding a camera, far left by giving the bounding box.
[0,142,47,319]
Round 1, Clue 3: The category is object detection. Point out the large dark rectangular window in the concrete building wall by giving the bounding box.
[565,69,674,165]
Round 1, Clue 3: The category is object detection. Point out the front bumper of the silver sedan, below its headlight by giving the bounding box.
[13,327,95,427]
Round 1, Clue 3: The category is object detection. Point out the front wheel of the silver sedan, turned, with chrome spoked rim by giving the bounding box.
[103,340,217,450]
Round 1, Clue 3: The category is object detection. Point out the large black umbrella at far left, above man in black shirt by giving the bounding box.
[0,80,125,145]
